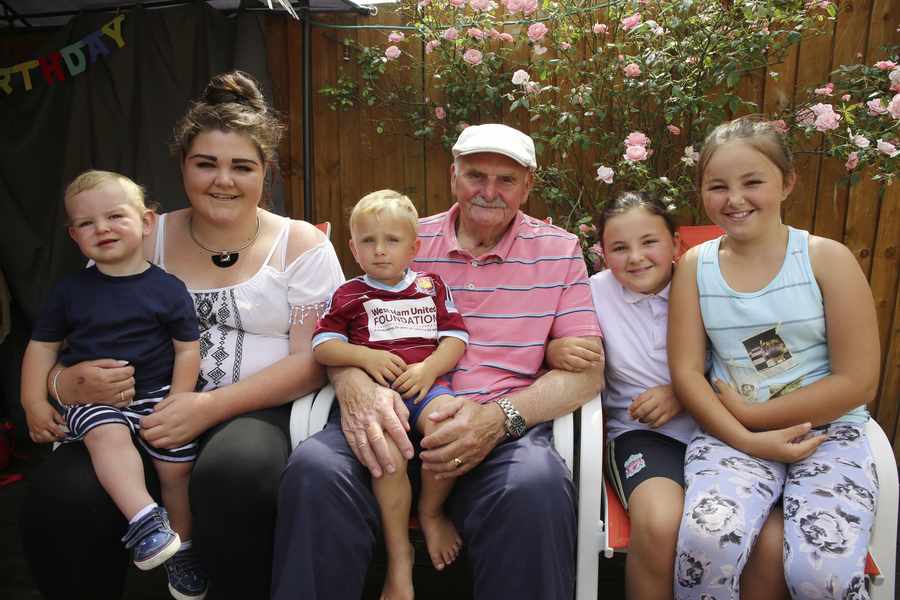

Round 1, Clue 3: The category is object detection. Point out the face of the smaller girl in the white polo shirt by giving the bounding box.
[603,208,678,294]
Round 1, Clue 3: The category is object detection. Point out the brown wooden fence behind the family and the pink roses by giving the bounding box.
[268,0,900,458]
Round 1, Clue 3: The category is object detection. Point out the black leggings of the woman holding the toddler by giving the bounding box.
[21,404,291,600]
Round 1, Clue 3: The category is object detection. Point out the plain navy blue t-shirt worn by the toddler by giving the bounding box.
[31,265,200,393]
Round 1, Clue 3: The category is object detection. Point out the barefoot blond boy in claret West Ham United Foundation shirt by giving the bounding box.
[312,190,468,600]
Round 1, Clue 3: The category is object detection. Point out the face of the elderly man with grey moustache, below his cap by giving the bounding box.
[450,152,534,235]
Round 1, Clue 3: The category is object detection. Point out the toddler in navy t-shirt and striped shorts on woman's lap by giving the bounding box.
[22,171,207,600]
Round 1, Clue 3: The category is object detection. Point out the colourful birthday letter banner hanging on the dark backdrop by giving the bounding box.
[0,15,125,96]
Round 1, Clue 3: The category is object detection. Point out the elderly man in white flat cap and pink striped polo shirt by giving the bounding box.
[273,124,603,600]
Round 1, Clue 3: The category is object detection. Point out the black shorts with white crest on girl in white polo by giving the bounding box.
[606,429,687,510]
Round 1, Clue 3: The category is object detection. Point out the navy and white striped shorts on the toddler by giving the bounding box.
[63,386,198,462]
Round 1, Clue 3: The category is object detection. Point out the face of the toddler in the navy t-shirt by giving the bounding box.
[66,181,152,275]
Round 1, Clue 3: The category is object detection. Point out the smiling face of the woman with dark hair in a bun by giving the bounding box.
[181,131,266,225]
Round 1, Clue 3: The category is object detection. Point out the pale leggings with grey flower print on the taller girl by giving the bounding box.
[674,423,878,600]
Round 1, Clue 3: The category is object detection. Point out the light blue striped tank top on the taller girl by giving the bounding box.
[697,227,869,423]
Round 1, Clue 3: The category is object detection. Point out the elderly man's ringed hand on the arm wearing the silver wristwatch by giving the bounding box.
[419,397,506,479]
